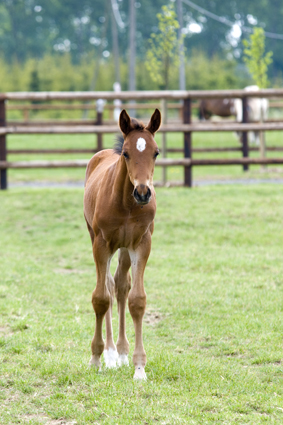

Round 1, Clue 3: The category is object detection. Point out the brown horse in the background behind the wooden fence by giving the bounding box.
[199,99,236,120]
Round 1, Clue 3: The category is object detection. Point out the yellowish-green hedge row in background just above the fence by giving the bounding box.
[0,51,253,92]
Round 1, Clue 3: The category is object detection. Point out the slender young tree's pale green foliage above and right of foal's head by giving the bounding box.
[145,4,181,90]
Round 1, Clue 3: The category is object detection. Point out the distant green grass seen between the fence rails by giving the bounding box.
[7,132,283,183]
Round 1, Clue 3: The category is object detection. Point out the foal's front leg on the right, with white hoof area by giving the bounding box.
[129,232,151,379]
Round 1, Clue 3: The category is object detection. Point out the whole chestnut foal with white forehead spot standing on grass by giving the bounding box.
[84,109,161,379]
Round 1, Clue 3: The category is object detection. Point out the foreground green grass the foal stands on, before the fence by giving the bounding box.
[0,184,283,425]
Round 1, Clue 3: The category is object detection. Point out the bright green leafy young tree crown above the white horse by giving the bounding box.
[243,28,273,88]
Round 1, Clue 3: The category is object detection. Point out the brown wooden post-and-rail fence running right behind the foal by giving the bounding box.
[0,89,283,189]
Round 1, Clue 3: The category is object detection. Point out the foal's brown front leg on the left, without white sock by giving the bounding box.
[90,235,112,368]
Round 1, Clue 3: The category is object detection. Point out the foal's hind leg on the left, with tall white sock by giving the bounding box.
[104,272,118,367]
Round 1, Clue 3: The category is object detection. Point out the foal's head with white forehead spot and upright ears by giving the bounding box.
[119,109,161,205]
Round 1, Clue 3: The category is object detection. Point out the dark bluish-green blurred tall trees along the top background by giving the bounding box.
[0,0,283,80]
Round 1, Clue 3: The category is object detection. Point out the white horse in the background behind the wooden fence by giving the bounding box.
[234,86,269,146]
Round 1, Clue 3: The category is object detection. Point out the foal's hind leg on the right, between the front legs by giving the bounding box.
[114,248,131,366]
